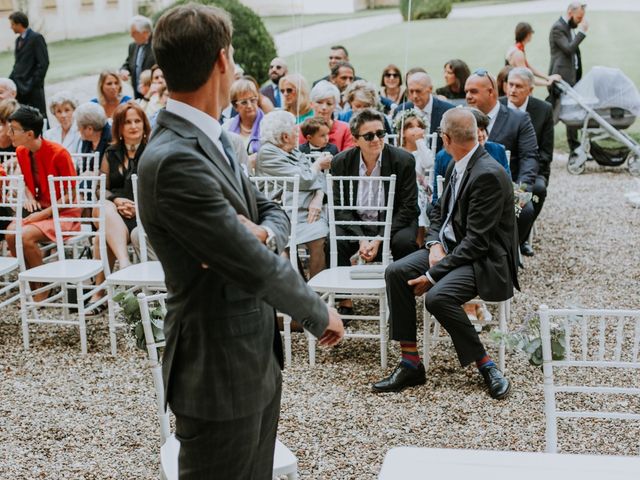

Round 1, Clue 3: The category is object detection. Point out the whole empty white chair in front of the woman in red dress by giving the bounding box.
[18,175,109,354]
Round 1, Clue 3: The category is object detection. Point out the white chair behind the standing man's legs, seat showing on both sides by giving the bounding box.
[138,293,298,480]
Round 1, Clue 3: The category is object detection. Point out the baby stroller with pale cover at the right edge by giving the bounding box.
[555,67,640,176]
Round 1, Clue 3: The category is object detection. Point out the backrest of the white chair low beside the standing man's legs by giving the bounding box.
[138,293,170,445]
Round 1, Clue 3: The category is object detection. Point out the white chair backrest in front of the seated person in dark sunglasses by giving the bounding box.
[327,174,396,268]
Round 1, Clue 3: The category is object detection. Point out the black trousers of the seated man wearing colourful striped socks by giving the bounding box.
[385,248,486,366]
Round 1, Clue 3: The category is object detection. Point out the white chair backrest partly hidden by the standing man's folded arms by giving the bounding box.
[250,175,300,270]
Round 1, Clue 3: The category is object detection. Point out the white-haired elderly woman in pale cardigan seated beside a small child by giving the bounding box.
[256,110,331,277]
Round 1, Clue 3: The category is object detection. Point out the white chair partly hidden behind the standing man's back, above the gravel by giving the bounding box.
[105,173,166,356]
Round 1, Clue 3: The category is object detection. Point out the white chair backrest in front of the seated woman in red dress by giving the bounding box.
[49,174,110,276]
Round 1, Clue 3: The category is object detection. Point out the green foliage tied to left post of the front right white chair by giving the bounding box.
[490,317,566,367]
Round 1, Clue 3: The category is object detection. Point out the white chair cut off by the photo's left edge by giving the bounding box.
[0,175,25,308]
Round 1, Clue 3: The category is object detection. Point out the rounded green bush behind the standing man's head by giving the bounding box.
[154,0,277,83]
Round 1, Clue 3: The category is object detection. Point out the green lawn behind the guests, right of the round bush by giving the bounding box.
[288,12,640,153]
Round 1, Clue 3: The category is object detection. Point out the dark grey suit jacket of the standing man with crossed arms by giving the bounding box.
[138,110,328,420]
